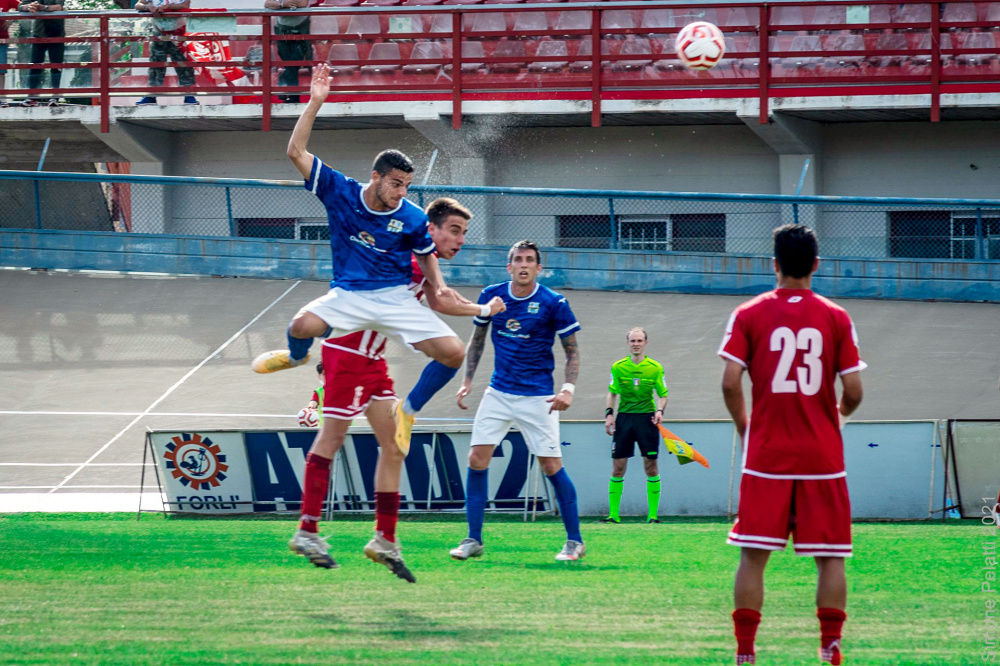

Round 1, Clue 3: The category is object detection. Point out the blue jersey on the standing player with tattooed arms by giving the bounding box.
[472,282,580,395]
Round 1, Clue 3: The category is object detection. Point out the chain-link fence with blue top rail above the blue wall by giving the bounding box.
[0,171,1000,261]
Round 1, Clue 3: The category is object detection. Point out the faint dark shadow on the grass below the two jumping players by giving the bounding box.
[306,608,515,643]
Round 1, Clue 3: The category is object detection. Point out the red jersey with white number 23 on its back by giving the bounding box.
[719,289,867,479]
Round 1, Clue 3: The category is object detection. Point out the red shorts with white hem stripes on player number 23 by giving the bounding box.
[726,473,852,557]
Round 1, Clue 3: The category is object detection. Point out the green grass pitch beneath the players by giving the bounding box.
[0,514,995,666]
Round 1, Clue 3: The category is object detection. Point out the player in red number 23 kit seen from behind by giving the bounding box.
[719,224,867,666]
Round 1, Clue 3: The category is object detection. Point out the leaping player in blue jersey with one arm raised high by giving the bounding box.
[253,64,503,454]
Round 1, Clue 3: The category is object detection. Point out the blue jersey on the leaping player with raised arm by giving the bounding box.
[306,157,434,291]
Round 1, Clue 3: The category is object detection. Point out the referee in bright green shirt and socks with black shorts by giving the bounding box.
[601,327,667,524]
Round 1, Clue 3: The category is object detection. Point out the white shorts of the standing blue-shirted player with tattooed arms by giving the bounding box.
[469,387,562,458]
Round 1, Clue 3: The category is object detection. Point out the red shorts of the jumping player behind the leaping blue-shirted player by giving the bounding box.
[323,345,396,421]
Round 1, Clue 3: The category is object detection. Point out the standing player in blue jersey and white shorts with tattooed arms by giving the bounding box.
[450,241,586,560]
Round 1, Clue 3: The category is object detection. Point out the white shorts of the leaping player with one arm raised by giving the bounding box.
[303,285,457,346]
